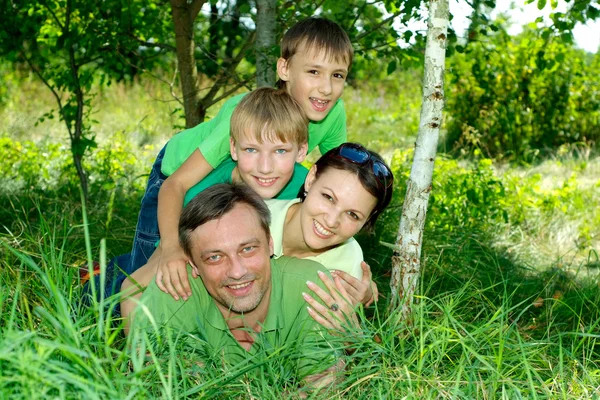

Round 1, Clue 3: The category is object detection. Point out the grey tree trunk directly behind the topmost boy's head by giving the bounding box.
[255,0,277,87]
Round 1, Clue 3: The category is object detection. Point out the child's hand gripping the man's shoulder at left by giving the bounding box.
[156,246,198,300]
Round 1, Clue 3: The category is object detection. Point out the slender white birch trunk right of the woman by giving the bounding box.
[390,0,449,320]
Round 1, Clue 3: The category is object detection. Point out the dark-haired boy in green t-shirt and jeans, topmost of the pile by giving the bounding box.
[126,18,353,298]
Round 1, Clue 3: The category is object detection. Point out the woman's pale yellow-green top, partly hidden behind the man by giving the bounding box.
[265,199,363,279]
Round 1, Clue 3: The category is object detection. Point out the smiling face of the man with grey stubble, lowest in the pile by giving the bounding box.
[191,204,273,316]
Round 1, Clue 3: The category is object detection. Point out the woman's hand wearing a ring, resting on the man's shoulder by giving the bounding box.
[302,271,359,331]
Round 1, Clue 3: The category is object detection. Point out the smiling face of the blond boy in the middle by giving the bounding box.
[230,135,307,199]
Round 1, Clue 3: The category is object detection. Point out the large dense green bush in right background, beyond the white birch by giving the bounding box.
[446,23,600,160]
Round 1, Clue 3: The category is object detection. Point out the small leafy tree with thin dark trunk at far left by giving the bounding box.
[0,0,122,198]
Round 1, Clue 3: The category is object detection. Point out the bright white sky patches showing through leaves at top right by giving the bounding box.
[450,0,600,53]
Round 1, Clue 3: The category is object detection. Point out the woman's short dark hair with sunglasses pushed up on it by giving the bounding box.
[298,142,394,231]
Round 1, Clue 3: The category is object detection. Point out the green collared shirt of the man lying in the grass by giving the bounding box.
[135,257,338,378]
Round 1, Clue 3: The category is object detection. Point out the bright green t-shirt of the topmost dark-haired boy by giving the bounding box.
[161,93,346,176]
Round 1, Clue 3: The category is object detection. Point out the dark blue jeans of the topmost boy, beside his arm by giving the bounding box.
[124,143,168,278]
